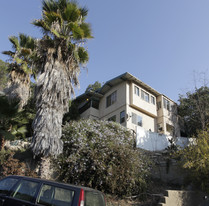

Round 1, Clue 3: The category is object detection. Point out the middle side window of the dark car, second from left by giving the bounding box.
[12,180,39,202]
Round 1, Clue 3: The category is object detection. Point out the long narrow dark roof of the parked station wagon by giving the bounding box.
[5,175,101,193]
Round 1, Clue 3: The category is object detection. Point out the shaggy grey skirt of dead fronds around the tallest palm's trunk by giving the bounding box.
[31,57,71,157]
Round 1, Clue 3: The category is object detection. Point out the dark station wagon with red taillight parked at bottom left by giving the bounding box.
[0,176,106,206]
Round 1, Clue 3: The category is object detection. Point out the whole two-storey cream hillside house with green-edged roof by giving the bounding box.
[75,73,180,136]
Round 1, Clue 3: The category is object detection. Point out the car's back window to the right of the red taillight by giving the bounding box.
[85,191,105,206]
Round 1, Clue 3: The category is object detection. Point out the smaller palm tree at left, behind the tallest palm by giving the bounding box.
[2,34,35,108]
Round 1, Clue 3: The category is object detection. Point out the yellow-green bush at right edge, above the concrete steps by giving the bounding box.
[174,128,209,192]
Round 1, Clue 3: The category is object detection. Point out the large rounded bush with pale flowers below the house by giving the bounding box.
[55,119,149,196]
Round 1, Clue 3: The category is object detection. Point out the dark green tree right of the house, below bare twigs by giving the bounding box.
[178,86,209,137]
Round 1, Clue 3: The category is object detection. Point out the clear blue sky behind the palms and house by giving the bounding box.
[0,0,209,101]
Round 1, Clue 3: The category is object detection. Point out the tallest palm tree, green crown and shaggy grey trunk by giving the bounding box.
[32,0,92,166]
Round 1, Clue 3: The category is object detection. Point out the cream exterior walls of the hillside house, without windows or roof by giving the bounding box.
[76,73,180,136]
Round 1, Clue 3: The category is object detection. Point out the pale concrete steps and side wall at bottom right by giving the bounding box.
[158,190,209,206]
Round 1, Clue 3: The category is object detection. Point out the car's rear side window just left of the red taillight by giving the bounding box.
[37,184,74,206]
